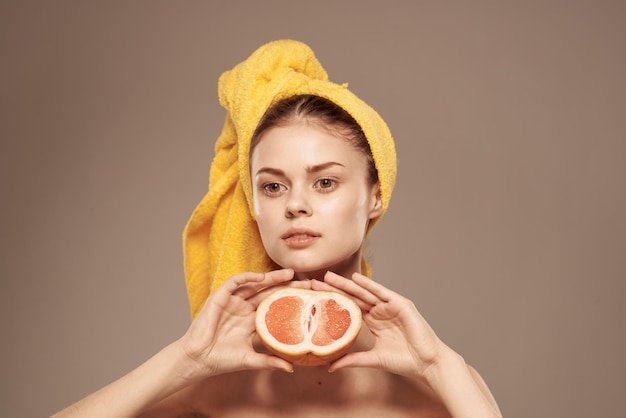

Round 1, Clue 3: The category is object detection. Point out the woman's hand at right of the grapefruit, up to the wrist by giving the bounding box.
[313,272,448,378]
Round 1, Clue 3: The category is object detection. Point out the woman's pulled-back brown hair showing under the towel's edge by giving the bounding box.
[250,94,378,184]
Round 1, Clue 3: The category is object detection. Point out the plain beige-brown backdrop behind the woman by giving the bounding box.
[0,0,626,417]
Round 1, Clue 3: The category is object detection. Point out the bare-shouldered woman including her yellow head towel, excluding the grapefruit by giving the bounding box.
[51,41,500,418]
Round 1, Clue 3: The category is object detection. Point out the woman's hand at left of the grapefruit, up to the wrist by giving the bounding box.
[180,269,294,378]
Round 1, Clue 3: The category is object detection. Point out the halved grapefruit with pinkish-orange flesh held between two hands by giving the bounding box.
[256,288,362,366]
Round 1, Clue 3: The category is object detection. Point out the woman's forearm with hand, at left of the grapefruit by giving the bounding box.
[53,270,293,418]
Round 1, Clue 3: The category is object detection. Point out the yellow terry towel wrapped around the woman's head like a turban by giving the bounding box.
[183,40,396,318]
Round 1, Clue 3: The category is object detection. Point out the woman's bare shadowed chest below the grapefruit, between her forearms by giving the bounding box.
[185,369,448,418]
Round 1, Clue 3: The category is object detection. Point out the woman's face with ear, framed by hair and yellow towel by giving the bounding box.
[250,121,381,278]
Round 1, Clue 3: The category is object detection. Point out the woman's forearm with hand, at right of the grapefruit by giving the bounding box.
[317,273,502,418]
